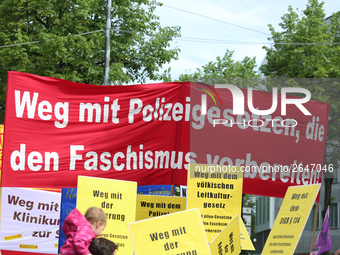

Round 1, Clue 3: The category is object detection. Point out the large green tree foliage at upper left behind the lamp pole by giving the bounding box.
[0,0,180,122]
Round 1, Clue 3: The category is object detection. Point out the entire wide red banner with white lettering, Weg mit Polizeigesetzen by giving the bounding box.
[1,72,329,197]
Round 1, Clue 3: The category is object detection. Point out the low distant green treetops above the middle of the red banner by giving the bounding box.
[162,50,259,84]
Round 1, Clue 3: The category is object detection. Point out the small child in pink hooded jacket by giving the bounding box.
[60,207,106,255]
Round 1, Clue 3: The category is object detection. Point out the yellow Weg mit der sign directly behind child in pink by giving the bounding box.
[77,176,137,255]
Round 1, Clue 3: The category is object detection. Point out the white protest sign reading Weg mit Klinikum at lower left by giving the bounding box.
[0,188,60,254]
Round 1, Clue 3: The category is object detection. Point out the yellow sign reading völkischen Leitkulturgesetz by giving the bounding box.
[187,164,243,242]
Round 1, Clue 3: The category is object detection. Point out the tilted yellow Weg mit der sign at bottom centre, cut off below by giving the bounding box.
[128,208,211,255]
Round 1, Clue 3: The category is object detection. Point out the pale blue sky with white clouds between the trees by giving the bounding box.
[150,0,340,80]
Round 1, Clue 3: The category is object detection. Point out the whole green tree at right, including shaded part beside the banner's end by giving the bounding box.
[260,0,340,223]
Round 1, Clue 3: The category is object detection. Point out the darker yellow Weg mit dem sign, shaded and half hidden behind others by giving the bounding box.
[136,195,186,221]
